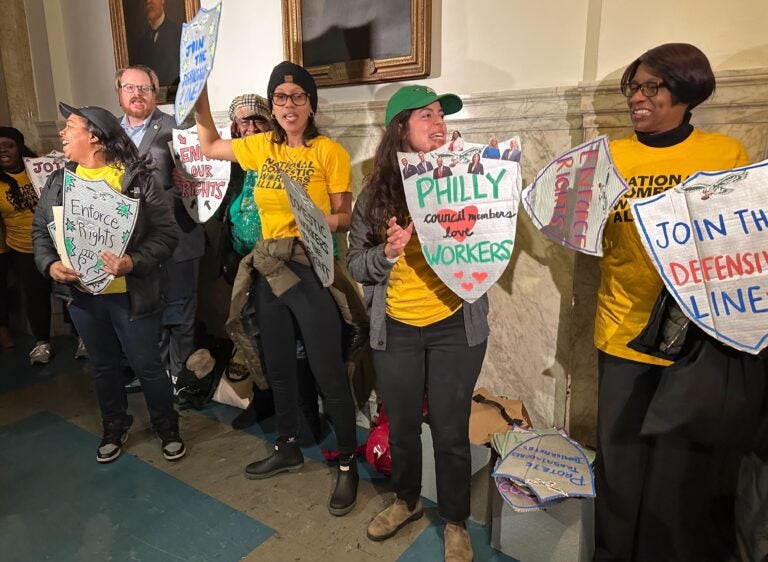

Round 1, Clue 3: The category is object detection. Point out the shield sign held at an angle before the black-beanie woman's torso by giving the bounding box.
[280,171,333,287]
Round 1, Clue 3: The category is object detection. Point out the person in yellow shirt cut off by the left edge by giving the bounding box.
[0,127,53,358]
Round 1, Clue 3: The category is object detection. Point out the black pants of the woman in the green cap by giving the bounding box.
[373,309,488,523]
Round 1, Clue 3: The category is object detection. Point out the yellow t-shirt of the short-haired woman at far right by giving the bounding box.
[595,129,749,365]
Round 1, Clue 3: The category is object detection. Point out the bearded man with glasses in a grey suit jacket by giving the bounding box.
[115,65,205,390]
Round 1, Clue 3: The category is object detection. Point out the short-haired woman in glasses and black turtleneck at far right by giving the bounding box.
[595,43,748,561]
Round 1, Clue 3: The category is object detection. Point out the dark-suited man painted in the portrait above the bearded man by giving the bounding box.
[131,0,181,86]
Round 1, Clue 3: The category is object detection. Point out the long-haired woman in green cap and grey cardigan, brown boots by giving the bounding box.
[348,86,488,560]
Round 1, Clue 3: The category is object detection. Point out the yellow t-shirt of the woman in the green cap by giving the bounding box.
[387,233,463,328]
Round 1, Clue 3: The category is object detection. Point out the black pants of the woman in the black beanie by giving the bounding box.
[256,262,356,457]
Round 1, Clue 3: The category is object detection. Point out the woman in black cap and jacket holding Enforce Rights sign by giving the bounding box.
[32,103,186,463]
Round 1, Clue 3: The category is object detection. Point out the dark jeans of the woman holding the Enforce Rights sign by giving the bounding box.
[69,289,178,430]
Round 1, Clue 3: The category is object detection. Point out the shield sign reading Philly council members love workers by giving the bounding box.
[397,139,521,302]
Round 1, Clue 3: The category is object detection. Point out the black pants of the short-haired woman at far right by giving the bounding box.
[594,352,734,562]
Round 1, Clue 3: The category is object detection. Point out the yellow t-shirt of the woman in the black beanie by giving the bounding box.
[232,134,352,238]
